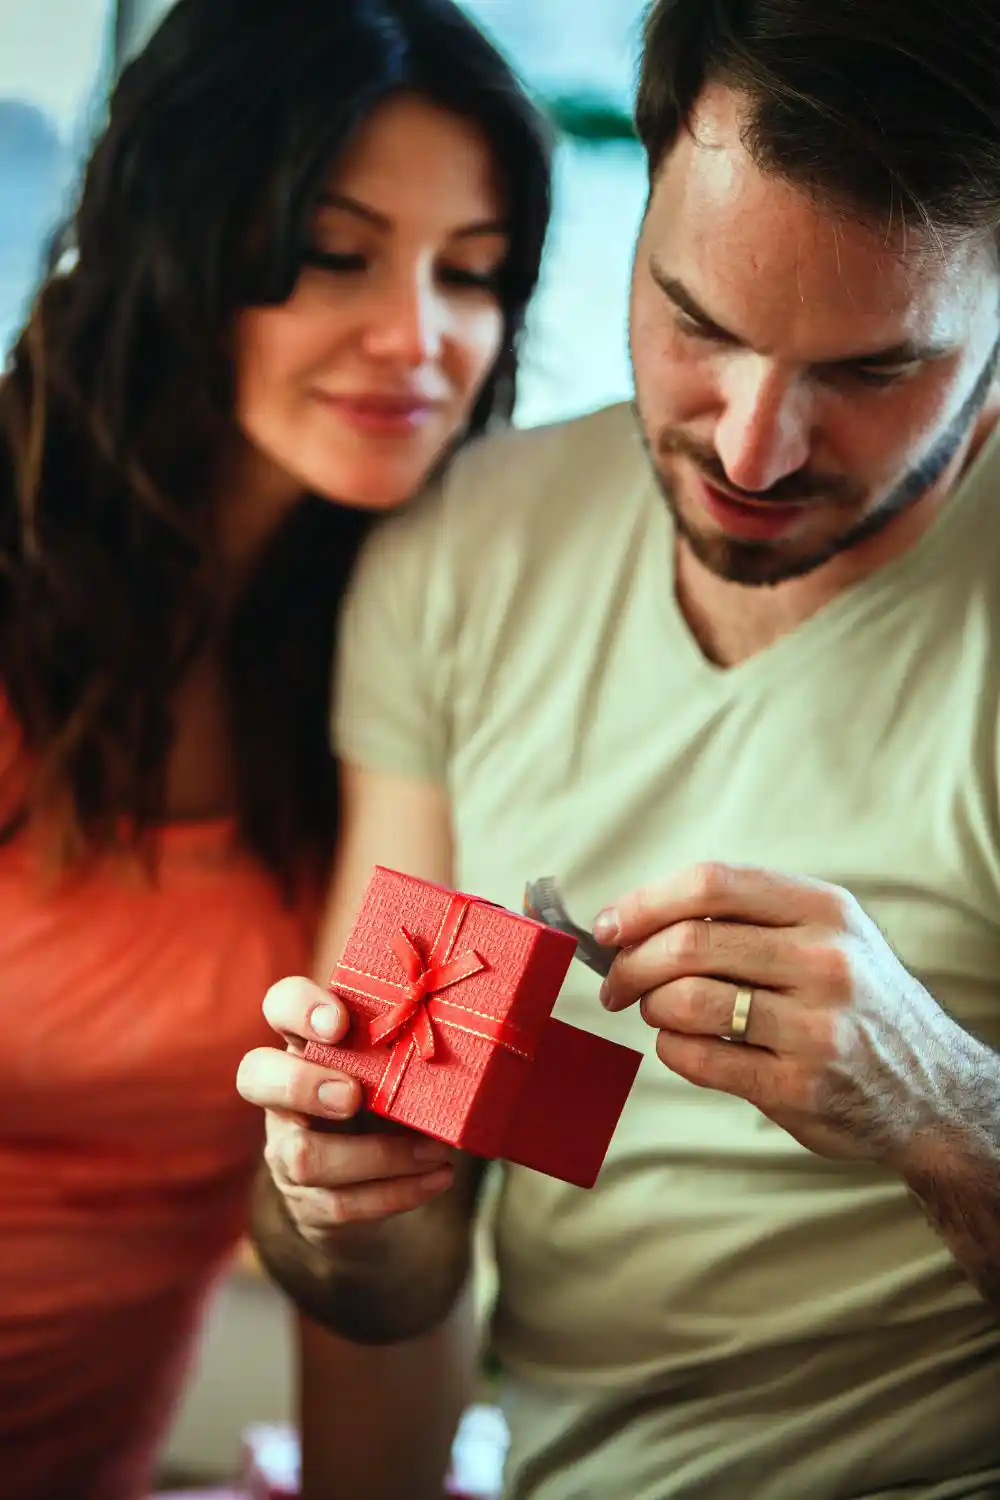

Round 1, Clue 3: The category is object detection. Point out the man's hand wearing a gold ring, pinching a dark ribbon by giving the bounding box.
[594,864,985,1176]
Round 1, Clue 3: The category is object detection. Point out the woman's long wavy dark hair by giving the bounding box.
[0,0,549,887]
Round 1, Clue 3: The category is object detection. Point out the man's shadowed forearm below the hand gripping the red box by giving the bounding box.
[253,1169,477,1344]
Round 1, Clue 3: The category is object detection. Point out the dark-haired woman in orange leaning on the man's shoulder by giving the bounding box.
[0,0,549,1500]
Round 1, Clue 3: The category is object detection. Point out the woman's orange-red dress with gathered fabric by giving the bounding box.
[0,699,312,1500]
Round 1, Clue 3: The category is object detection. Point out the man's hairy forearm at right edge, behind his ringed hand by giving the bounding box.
[904,1037,1000,1311]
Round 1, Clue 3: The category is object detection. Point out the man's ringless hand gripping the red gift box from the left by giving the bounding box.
[237,980,453,1245]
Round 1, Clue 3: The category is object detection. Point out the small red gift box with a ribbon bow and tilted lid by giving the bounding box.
[306,866,642,1188]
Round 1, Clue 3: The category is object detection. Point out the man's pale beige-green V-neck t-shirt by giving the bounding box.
[334,407,1000,1500]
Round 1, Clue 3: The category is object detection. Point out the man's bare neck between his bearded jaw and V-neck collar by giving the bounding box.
[675,399,1000,668]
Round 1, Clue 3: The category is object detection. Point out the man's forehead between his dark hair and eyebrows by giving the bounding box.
[646,90,997,342]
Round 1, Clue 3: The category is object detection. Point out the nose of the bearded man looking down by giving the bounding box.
[715,354,811,492]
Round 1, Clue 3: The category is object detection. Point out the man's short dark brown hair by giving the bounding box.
[636,0,1000,236]
